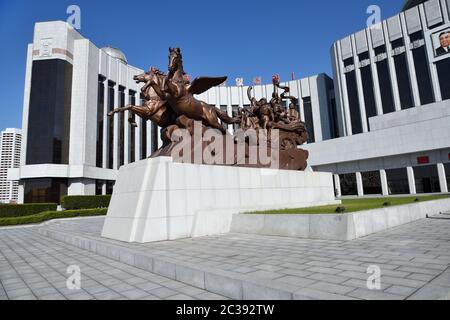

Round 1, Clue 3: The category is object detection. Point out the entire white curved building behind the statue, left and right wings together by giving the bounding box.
[6,0,450,202]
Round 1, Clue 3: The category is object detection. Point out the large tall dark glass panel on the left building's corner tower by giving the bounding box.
[26,59,73,164]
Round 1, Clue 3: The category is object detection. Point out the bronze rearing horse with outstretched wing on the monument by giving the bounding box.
[150,48,239,134]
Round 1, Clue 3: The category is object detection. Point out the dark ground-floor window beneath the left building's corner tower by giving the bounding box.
[23,178,68,203]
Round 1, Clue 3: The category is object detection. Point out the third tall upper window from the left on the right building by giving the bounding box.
[375,46,395,114]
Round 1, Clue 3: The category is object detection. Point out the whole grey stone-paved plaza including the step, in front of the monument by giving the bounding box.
[0,217,450,300]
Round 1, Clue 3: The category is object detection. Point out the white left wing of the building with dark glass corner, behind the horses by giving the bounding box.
[9,21,157,203]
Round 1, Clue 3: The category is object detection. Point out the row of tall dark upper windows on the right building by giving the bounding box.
[344,31,450,134]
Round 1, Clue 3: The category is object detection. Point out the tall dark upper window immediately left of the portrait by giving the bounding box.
[410,31,435,105]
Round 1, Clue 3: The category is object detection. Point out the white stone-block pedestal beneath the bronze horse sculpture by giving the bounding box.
[102,157,339,243]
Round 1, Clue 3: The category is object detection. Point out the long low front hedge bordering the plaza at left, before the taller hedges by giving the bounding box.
[0,208,108,226]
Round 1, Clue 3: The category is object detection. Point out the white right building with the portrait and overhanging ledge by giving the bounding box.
[307,0,450,195]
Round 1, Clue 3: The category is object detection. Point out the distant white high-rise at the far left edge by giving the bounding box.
[0,128,22,203]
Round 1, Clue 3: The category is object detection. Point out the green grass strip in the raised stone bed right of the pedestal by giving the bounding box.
[249,195,450,214]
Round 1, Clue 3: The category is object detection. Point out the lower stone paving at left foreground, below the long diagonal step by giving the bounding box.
[0,228,226,300]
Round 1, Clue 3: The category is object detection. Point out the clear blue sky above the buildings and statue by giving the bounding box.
[0,0,403,129]
